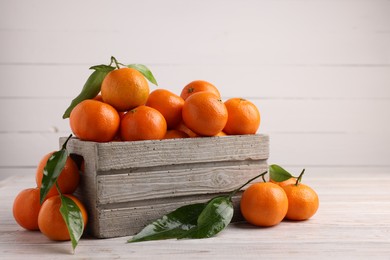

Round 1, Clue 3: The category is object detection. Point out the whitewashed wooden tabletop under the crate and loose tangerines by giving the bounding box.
[0,168,390,259]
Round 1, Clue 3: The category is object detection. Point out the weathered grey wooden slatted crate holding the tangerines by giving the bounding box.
[60,135,269,238]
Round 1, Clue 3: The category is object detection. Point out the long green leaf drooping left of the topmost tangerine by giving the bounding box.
[62,68,115,119]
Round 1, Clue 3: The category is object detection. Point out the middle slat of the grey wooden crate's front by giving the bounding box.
[97,160,267,205]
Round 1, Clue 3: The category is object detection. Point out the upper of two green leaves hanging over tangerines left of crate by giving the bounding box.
[40,149,68,204]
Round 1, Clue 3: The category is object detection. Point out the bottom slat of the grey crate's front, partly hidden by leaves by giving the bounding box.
[92,194,242,238]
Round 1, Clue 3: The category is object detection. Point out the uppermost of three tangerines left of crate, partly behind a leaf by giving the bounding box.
[35,152,80,197]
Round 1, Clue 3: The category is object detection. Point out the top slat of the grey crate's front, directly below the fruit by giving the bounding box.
[97,135,269,171]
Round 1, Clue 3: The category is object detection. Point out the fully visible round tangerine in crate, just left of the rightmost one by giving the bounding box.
[182,92,228,136]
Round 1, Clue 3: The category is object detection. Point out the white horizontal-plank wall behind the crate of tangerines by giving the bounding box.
[0,0,390,178]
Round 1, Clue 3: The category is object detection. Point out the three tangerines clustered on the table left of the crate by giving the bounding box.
[13,153,88,241]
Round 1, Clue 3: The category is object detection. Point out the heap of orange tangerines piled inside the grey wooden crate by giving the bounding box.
[69,67,260,142]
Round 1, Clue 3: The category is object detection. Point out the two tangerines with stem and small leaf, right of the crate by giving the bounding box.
[244,165,319,227]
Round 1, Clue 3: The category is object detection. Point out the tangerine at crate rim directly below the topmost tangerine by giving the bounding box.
[120,106,167,141]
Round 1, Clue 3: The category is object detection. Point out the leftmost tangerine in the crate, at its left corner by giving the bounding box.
[69,99,120,142]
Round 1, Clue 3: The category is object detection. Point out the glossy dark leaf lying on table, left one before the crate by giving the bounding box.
[127,203,206,242]
